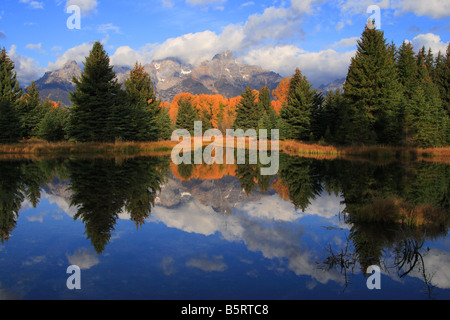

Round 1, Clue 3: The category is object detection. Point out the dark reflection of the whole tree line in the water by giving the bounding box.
[0,154,450,288]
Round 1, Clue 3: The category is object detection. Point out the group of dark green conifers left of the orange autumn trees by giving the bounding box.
[0,42,172,143]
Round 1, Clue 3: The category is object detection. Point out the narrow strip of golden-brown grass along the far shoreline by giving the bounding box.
[0,140,450,163]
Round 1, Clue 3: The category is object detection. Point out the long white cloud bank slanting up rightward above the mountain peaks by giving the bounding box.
[136,0,316,65]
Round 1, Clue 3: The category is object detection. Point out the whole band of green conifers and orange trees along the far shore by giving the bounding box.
[0,27,450,148]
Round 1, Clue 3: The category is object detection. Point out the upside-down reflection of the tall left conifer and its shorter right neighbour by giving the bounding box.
[68,158,168,253]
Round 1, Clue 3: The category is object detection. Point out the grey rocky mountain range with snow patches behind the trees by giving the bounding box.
[35,51,343,106]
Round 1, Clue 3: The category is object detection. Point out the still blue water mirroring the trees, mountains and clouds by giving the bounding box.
[0,154,450,300]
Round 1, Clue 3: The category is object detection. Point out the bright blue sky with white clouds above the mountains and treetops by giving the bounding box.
[0,0,450,86]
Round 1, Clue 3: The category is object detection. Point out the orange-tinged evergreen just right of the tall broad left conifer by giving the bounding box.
[125,63,160,141]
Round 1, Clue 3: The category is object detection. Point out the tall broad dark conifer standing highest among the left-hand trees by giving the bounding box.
[67,41,130,142]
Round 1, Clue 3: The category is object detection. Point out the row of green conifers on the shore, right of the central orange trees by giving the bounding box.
[230,27,450,147]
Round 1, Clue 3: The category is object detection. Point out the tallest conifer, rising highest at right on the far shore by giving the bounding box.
[344,27,400,144]
